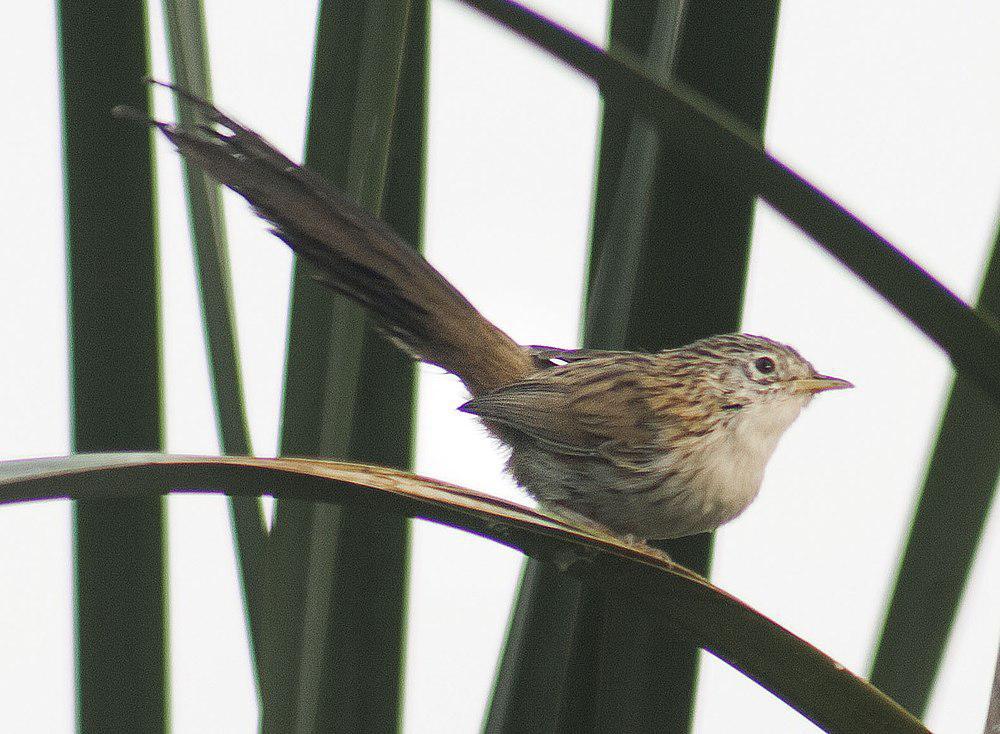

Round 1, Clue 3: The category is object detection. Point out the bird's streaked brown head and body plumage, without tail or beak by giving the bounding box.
[461,334,840,538]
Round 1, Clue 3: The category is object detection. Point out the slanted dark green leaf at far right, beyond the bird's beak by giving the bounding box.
[871,221,1000,716]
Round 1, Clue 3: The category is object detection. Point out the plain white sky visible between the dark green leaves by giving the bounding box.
[0,0,1000,734]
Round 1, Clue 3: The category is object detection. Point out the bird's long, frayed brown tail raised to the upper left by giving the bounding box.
[115,84,533,395]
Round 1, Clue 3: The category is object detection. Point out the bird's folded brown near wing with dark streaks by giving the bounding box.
[460,353,658,457]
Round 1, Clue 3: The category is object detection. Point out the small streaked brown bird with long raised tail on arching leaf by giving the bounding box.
[114,82,853,547]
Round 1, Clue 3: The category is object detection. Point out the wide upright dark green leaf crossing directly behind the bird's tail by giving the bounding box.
[264,0,416,732]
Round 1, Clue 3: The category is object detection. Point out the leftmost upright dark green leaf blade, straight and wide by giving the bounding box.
[59,0,166,732]
